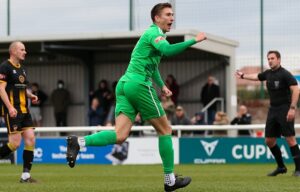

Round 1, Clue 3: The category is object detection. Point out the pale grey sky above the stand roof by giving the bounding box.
[0,0,300,68]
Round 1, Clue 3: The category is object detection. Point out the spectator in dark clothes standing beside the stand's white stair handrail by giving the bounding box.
[201,76,220,125]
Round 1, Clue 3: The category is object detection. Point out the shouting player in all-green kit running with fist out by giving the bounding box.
[67,3,206,191]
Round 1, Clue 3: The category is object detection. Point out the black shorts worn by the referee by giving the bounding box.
[265,105,295,137]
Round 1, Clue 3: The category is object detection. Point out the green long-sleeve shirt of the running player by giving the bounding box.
[120,24,196,88]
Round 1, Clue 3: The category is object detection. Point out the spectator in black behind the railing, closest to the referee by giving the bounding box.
[230,105,252,136]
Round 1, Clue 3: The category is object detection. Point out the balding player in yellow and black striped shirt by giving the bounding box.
[0,41,38,183]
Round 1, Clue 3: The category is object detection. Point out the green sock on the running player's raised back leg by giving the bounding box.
[84,131,117,146]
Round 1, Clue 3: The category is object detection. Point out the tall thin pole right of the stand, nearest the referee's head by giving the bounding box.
[260,0,265,99]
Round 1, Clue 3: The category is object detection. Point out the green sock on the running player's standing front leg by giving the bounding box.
[158,135,174,174]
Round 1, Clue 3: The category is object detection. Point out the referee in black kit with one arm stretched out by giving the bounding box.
[235,51,300,177]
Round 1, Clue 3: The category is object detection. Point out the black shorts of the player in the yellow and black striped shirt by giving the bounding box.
[4,113,33,134]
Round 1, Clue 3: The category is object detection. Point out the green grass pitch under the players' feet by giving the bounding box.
[0,164,300,192]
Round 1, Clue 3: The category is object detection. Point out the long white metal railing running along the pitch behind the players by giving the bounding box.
[0,124,300,137]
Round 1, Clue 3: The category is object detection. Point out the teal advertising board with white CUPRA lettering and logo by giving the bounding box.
[179,137,300,164]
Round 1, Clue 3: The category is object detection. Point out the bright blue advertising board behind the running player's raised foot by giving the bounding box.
[17,138,113,164]
